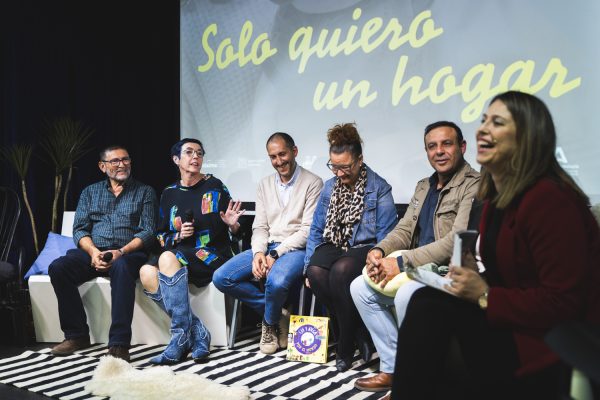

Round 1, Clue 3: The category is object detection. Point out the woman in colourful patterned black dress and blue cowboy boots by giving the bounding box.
[140,139,244,364]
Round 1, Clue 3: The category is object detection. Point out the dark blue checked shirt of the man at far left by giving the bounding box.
[73,178,158,249]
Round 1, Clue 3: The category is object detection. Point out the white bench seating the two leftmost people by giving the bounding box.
[29,212,229,346]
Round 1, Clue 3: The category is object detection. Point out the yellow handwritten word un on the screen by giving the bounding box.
[313,79,377,111]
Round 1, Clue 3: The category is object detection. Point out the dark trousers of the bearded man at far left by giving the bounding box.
[48,249,148,347]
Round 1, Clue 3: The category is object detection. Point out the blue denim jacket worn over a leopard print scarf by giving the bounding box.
[304,166,398,272]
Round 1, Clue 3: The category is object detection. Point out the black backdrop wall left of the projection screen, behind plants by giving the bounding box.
[0,0,179,263]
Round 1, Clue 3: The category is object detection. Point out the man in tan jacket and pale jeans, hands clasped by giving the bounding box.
[350,121,479,392]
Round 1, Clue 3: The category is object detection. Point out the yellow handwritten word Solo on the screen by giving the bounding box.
[198,21,277,72]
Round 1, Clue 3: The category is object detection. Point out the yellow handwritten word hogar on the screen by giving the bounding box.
[391,56,581,122]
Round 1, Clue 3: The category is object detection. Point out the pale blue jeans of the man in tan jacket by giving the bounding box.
[350,275,424,374]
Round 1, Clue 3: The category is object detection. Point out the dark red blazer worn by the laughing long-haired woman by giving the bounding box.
[487,179,593,333]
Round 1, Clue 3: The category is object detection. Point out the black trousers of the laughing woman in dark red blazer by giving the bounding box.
[392,287,562,399]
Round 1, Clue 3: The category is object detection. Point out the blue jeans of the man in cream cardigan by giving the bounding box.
[213,243,305,325]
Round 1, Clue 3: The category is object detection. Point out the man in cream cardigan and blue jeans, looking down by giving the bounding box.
[213,132,323,354]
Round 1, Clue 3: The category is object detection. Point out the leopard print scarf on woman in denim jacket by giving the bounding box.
[323,164,367,250]
